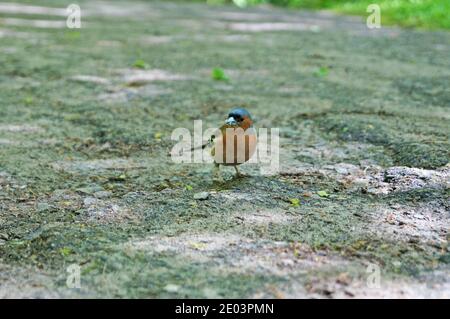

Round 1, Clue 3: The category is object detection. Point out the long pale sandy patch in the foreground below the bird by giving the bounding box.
[125,234,345,275]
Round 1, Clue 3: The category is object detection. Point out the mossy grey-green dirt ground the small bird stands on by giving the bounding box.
[0,0,450,298]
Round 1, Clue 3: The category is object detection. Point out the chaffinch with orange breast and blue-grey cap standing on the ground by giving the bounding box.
[209,108,256,180]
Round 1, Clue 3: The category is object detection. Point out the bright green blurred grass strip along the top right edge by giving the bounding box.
[198,0,450,29]
